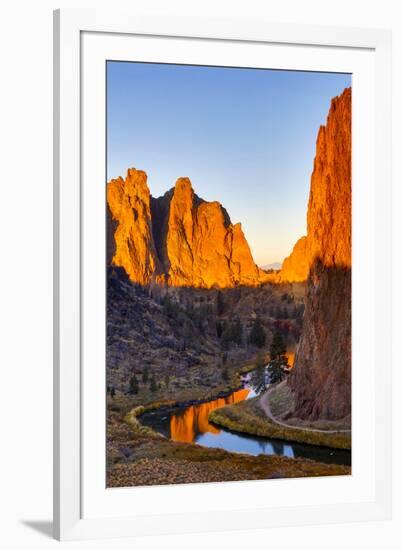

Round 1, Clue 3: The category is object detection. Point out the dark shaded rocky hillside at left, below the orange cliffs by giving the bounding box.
[106,267,220,391]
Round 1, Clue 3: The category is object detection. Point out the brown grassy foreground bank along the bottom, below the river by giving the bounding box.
[107,396,350,487]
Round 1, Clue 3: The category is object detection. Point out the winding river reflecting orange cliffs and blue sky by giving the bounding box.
[140,367,351,466]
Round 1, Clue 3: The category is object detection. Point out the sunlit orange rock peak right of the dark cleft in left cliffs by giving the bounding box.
[165,178,259,288]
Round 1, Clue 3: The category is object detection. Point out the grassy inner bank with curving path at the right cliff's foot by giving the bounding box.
[209,383,351,450]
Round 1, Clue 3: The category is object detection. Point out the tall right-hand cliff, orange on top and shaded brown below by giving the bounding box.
[284,88,352,419]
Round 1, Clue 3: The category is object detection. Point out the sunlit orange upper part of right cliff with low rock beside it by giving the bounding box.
[277,88,352,282]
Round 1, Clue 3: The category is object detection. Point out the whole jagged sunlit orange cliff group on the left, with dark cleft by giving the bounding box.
[107,169,266,288]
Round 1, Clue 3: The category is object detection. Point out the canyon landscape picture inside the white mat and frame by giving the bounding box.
[102,61,352,488]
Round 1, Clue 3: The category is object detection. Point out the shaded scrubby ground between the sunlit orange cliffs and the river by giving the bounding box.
[106,267,304,396]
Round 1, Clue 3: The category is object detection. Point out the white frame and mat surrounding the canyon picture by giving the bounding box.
[54,10,391,540]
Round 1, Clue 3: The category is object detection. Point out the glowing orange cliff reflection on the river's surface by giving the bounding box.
[170,388,250,443]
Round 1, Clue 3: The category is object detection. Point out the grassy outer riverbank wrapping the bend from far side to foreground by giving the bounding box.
[107,363,350,487]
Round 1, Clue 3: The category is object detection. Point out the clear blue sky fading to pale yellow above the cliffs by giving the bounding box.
[107,62,351,265]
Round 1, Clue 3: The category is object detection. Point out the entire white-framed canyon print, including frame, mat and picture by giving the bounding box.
[54,10,391,539]
